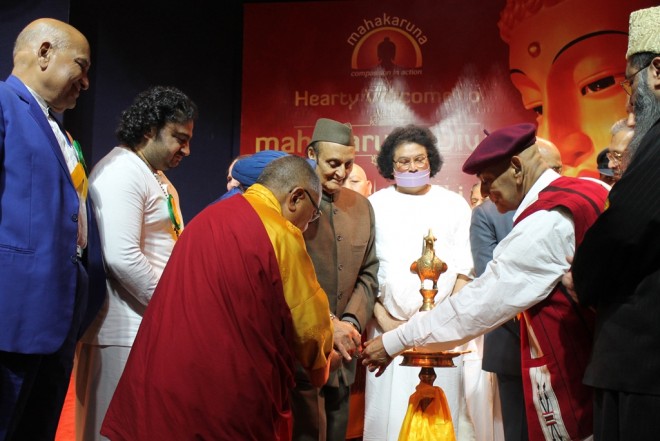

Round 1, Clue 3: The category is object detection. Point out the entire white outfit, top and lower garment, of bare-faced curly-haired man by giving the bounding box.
[76,147,181,441]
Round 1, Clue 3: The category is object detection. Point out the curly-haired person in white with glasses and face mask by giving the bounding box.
[364,125,496,441]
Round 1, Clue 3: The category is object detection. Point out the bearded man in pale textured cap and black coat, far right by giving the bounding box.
[572,7,660,440]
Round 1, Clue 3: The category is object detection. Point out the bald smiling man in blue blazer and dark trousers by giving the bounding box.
[0,19,104,440]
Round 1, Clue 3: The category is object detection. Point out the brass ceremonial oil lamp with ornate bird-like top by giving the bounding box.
[401,229,469,411]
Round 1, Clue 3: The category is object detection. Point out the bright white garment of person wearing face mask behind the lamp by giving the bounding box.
[364,186,472,441]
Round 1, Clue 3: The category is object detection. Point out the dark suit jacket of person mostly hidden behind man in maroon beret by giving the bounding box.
[470,199,521,375]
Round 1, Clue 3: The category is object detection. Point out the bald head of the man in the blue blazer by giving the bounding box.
[12,18,90,112]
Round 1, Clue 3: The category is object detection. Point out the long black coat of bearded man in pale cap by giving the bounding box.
[573,120,660,395]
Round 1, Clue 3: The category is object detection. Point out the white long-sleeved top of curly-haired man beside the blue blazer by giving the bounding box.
[84,147,181,346]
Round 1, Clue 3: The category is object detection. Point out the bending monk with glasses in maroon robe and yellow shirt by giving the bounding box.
[101,156,333,441]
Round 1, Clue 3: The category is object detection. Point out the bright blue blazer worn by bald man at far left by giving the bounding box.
[0,75,105,354]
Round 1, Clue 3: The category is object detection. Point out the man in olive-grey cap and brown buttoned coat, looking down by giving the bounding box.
[292,118,378,441]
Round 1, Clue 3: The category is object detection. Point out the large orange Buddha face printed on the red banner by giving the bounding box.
[498,0,654,177]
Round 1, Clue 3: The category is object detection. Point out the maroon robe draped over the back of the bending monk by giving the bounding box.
[101,196,295,441]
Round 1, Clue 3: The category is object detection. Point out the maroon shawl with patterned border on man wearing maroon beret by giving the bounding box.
[516,177,607,441]
